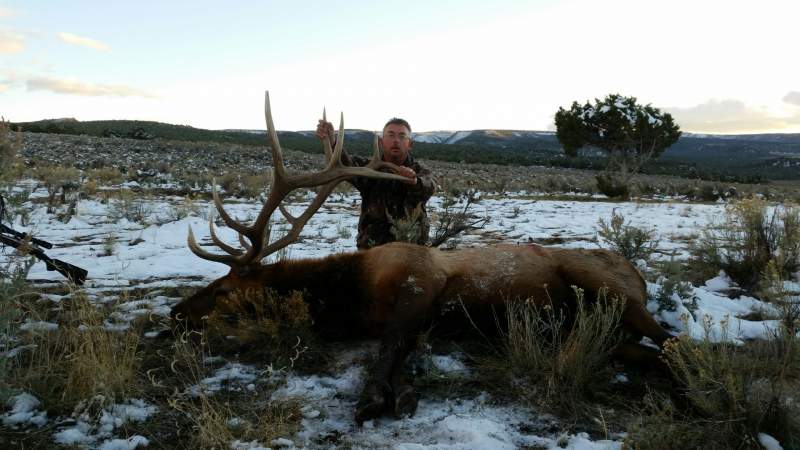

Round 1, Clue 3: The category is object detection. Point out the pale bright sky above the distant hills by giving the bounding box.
[0,0,800,133]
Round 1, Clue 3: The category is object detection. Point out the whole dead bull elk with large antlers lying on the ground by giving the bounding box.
[171,92,671,423]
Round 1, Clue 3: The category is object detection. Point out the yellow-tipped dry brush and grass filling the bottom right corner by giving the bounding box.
[627,322,800,449]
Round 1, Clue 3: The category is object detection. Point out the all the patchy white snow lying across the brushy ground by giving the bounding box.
[0,185,800,450]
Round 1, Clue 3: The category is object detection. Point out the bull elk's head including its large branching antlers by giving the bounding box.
[176,91,406,324]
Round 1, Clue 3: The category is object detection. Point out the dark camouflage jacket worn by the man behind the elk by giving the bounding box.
[342,152,435,249]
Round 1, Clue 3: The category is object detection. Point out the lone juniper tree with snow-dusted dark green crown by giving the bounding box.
[555,94,681,196]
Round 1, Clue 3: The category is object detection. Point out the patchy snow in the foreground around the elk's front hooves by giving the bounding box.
[266,342,621,450]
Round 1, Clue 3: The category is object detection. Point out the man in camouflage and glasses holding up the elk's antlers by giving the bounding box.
[317,118,435,249]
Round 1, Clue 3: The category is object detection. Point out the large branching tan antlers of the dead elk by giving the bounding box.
[188,91,407,269]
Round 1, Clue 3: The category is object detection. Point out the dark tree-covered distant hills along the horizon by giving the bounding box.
[12,118,800,181]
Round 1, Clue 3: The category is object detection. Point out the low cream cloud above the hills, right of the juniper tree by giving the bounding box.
[663,99,800,133]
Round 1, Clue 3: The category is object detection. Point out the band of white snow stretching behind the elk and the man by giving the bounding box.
[0,188,724,288]
